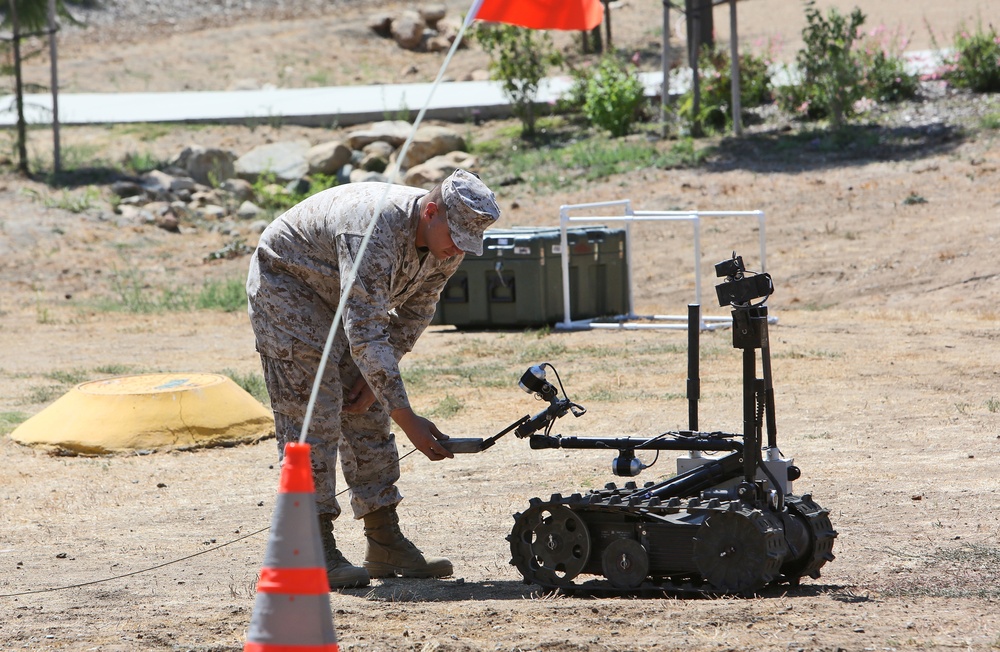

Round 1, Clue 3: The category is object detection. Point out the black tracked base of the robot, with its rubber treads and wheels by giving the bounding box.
[508,482,837,596]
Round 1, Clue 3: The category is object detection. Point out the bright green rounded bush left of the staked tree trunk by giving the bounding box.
[573,54,645,137]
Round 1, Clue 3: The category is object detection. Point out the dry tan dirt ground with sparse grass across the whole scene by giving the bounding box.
[0,0,1000,652]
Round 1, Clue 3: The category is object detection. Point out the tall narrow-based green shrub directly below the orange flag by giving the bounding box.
[474,25,563,136]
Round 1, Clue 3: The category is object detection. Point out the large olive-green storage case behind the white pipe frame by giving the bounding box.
[431,226,629,328]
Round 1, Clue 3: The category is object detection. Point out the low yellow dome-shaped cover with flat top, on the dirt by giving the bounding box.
[10,373,274,454]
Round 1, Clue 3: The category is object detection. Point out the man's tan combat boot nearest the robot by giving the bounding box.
[364,505,453,577]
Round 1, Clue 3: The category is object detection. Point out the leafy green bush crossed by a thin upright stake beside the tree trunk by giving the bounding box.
[679,47,773,130]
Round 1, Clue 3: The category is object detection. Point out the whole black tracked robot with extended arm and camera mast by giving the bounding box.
[452,254,837,595]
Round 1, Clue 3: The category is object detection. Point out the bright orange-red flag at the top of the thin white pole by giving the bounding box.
[476,0,604,31]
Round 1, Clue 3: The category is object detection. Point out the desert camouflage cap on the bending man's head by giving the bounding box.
[441,169,500,256]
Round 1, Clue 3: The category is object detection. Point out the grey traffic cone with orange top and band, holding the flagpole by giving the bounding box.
[243,442,339,652]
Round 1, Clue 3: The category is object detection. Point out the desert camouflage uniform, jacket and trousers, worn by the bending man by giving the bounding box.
[247,183,463,518]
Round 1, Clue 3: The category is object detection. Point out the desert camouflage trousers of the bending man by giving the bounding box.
[260,335,402,518]
